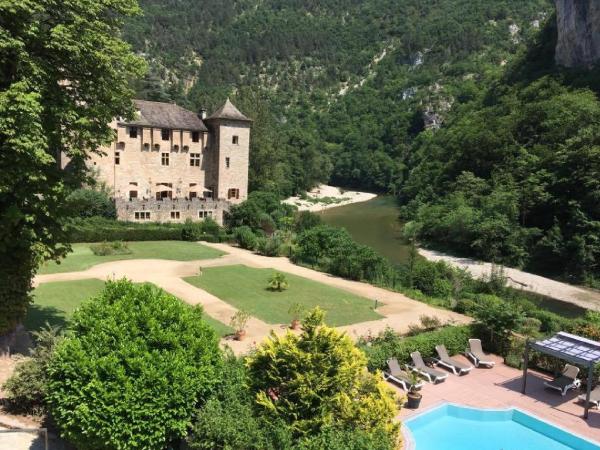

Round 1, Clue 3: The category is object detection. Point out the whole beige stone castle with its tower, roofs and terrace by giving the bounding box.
[88,100,251,224]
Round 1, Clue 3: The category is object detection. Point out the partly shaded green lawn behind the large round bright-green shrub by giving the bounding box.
[25,279,233,336]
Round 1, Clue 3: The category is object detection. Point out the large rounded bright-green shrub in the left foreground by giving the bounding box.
[47,280,222,450]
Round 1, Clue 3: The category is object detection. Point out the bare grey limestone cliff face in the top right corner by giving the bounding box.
[555,0,600,67]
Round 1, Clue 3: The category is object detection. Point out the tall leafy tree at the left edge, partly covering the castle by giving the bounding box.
[0,0,144,335]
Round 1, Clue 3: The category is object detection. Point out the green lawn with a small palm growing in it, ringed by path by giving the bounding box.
[185,265,382,326]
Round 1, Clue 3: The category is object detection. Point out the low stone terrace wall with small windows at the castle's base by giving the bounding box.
[115,198,230,225]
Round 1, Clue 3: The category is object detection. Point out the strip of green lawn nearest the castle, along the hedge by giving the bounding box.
[39,241,224,274]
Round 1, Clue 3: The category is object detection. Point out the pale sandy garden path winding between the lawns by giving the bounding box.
[34,243,470,353]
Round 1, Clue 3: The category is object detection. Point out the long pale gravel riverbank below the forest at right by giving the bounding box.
[419,248,600,311]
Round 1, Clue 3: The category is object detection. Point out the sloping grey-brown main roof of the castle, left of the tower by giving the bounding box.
[127,100,208,131]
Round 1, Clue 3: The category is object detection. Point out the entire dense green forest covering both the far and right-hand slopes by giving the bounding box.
[126,0,600,284]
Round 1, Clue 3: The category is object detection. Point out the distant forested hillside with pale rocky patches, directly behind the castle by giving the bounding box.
[126,0,552,195]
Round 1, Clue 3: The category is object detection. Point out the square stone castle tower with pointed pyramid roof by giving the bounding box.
[204,99,252,203]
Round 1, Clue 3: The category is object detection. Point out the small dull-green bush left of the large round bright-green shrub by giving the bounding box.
[2,325,61,415]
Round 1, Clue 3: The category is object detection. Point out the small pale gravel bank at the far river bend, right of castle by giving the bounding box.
[283,184,377,212]
